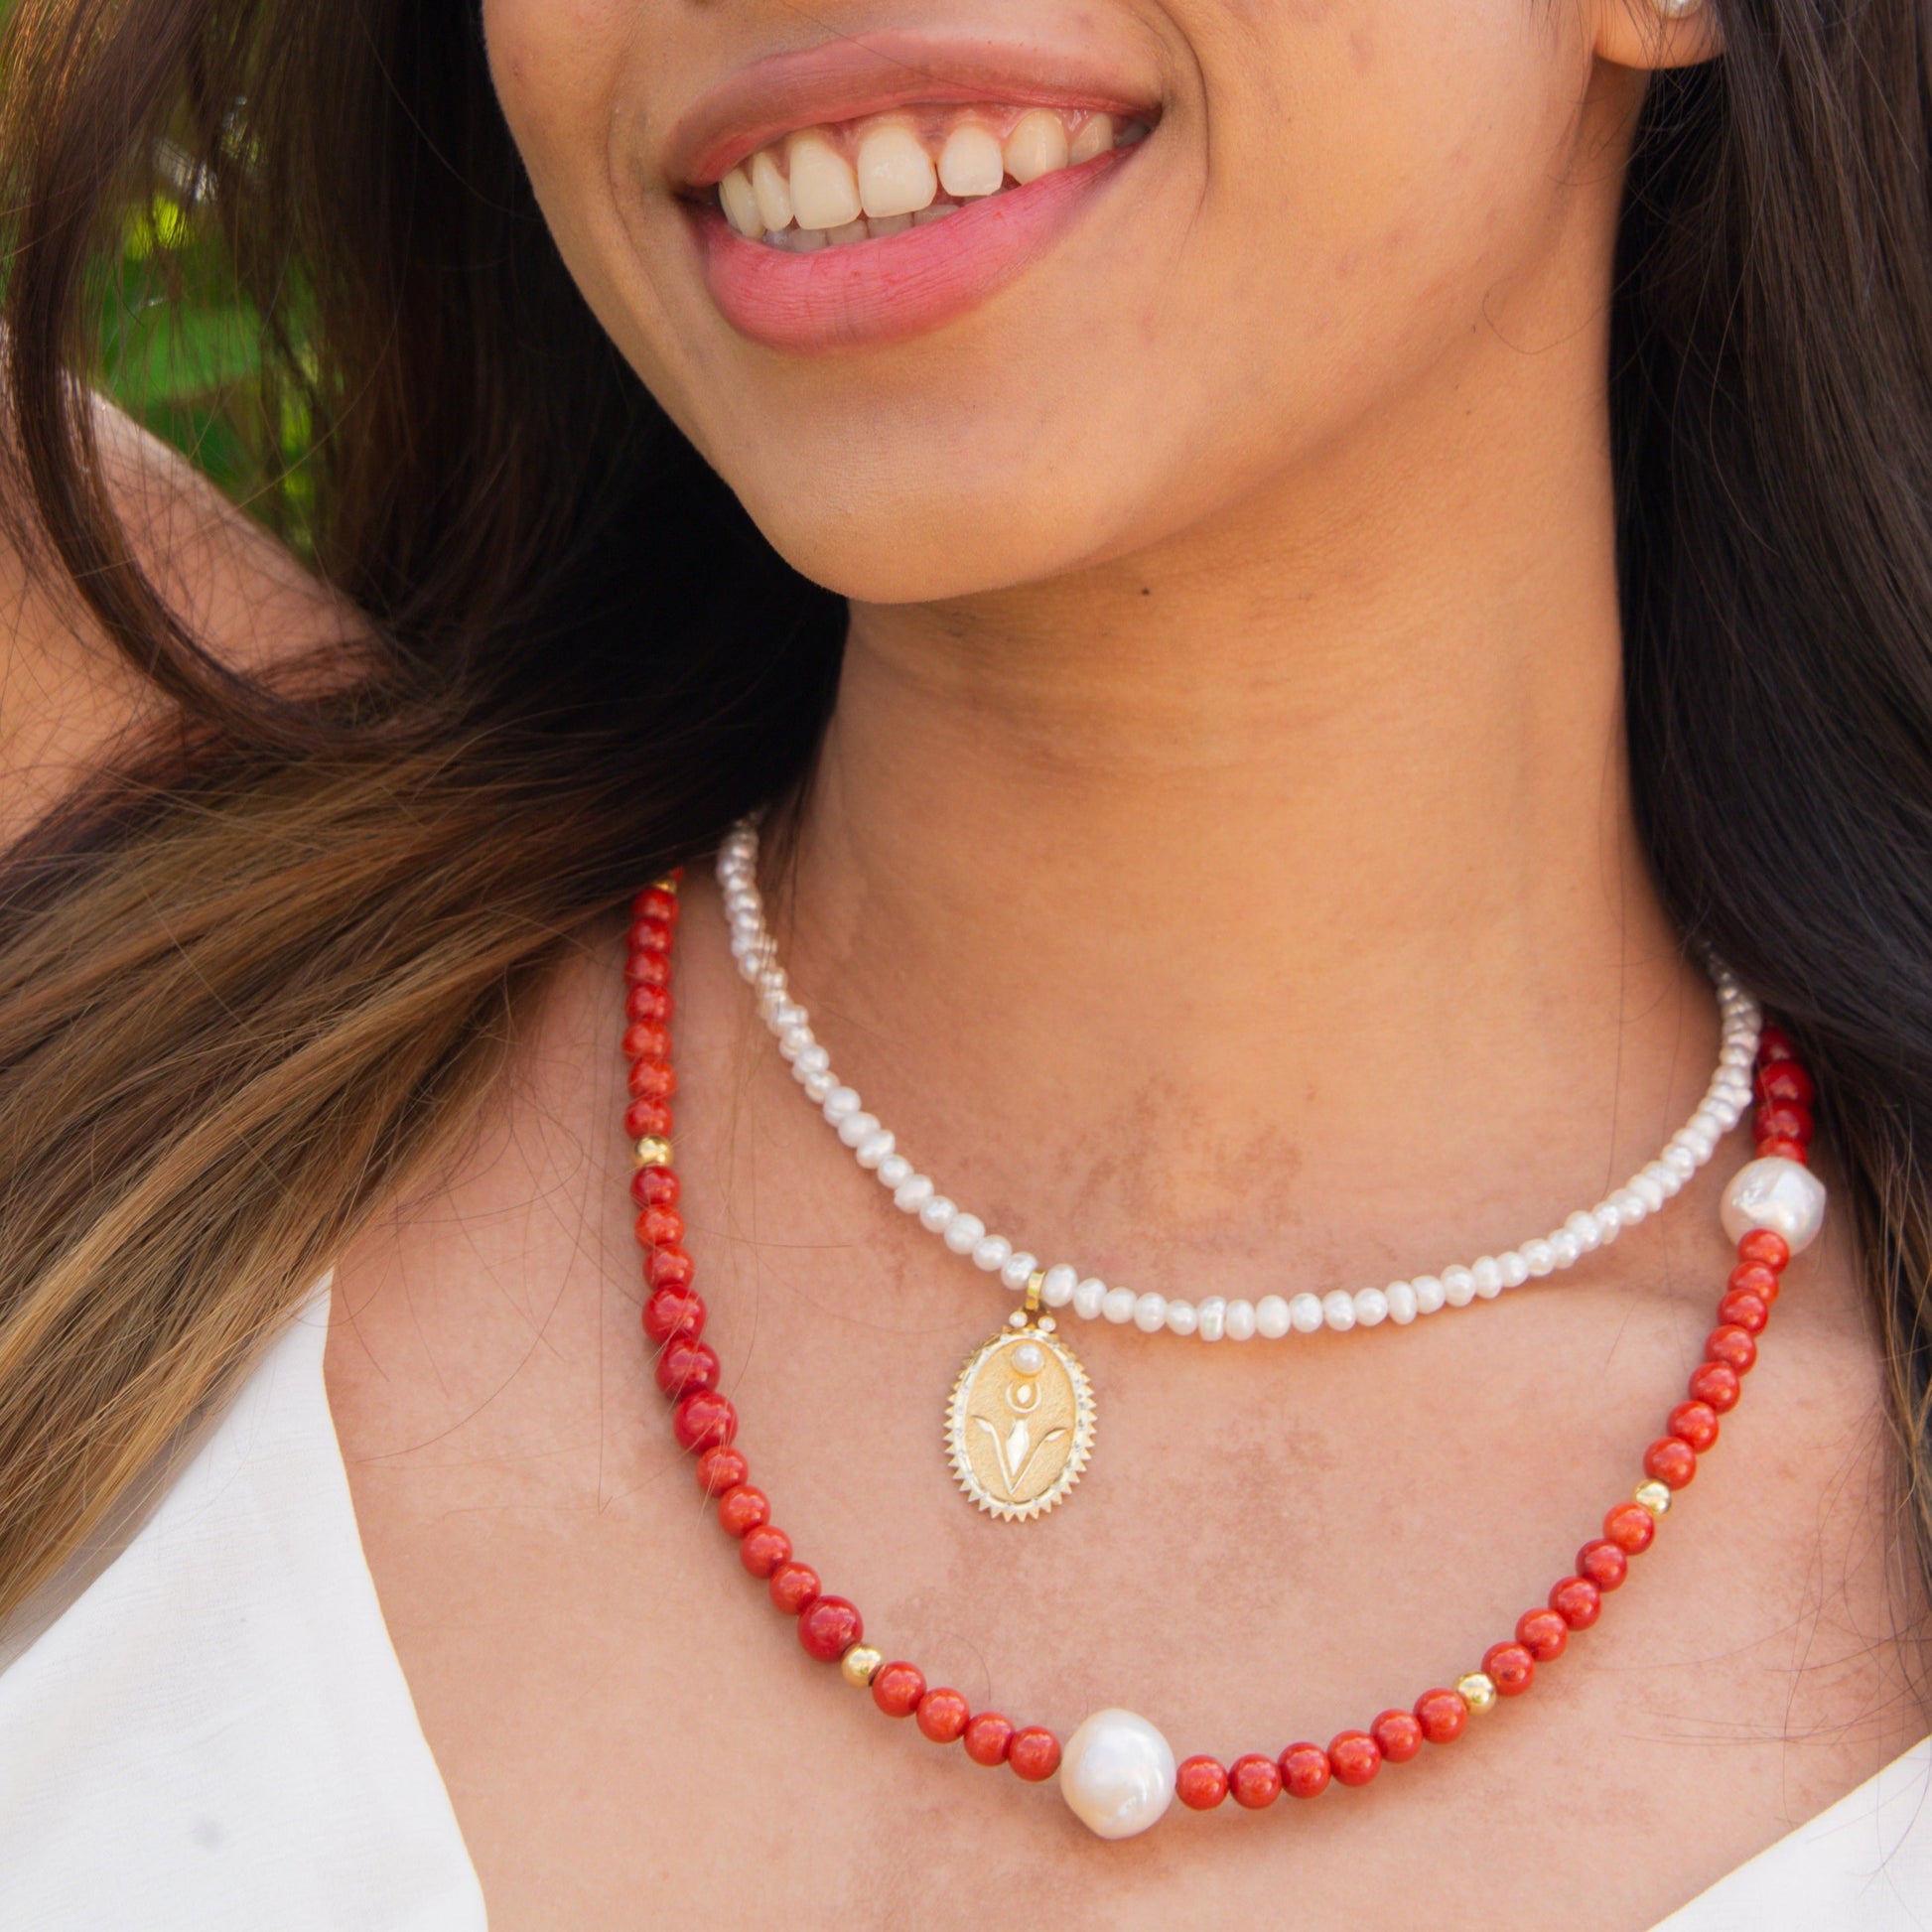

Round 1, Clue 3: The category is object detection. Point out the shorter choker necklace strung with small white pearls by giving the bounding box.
[717,823,1762,1341]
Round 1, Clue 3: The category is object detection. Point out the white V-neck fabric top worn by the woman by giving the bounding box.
[0,1285,1932,1932]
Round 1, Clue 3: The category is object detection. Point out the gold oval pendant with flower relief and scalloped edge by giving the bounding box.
[947,1315,1093,1522]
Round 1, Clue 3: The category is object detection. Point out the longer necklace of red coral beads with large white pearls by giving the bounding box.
[624,874,1824,1838]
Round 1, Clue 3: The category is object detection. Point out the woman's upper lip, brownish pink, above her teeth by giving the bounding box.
[664,33,1156,188]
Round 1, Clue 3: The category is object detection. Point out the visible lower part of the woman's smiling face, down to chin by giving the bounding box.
[483,0,1648,601]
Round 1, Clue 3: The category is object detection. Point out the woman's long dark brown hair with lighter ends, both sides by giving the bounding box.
[0,0,1932,1609]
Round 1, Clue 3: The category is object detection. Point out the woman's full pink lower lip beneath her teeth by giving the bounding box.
[692,143,1140,353]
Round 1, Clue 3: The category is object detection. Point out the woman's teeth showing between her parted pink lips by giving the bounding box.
[707,102,1150,255]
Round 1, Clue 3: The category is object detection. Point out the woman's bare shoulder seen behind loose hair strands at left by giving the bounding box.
[0,402,367,846]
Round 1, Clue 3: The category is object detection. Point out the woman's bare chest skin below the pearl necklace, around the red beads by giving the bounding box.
[331,997,1922,1932]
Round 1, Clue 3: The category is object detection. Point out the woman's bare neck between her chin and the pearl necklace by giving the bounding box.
[768,264,1714,1268]
